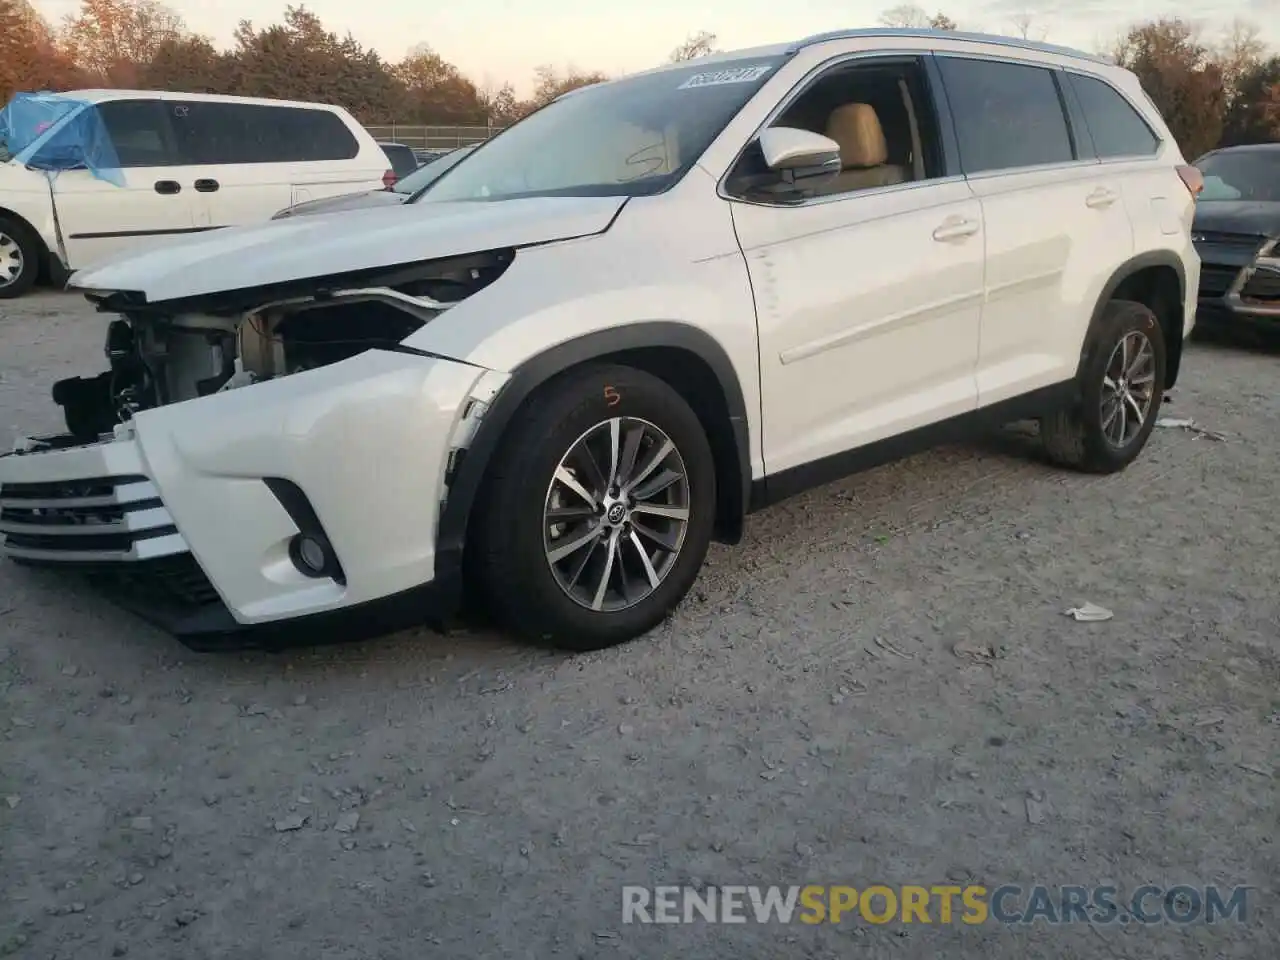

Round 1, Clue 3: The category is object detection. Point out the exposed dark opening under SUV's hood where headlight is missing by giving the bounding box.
[54,250,515,443]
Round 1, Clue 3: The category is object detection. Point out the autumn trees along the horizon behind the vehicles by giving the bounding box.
[0,0,1280,159]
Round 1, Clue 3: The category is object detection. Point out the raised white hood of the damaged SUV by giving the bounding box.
[69,197,626,303]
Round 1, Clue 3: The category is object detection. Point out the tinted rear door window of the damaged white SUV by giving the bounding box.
[938,56,1075,174]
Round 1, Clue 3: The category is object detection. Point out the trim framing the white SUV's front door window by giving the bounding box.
[716,47,964,210]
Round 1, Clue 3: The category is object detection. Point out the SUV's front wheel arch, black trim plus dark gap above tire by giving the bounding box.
[435,320,751,576]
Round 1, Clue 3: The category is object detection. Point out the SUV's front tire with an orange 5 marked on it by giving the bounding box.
[467,365,716,652]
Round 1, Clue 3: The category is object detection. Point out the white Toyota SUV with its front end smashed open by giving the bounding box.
[0,29,1199,649]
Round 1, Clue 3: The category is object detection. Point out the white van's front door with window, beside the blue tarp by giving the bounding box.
[54,100,196,270]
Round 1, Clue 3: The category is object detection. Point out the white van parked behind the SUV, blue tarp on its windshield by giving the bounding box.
[0,90,390,300]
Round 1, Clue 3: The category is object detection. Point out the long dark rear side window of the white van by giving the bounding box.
[168,101,360,164]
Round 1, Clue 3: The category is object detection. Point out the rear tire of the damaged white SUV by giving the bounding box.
[1041,300,1167,474]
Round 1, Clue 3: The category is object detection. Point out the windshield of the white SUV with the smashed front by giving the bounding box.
[415,56,785,204]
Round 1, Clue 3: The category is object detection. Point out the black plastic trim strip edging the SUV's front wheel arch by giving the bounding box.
[435,320,751,576]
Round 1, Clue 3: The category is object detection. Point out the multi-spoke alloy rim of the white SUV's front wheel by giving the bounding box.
[543,417,690,612]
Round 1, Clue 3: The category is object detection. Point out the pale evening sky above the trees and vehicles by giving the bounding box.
[27,0,1280,95]
